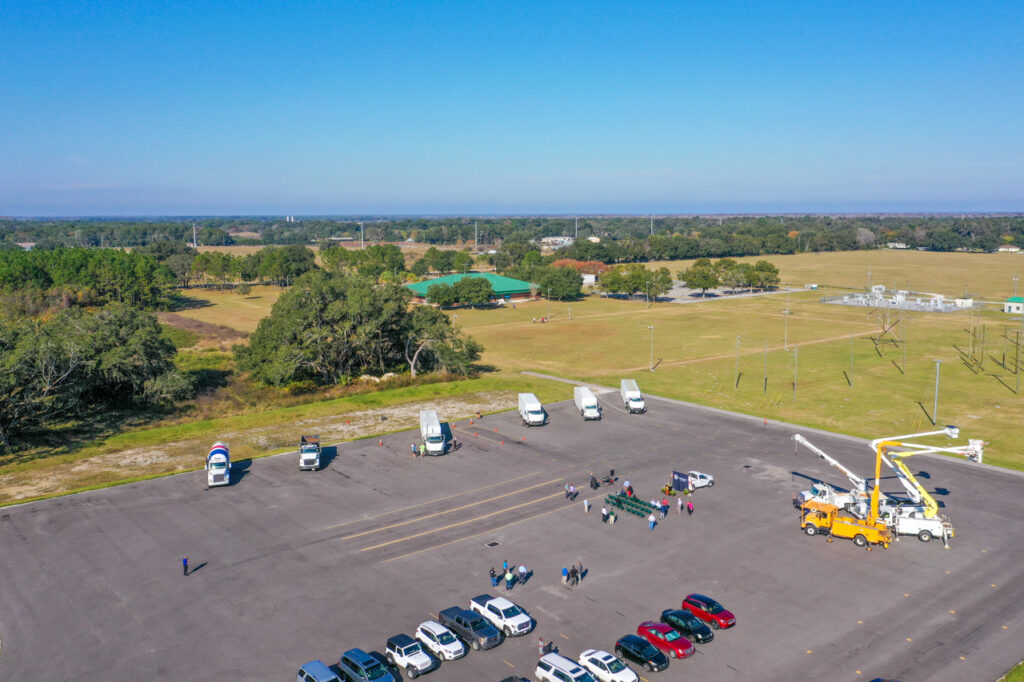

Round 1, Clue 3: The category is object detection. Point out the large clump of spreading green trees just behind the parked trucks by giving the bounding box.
[234,270,481,386]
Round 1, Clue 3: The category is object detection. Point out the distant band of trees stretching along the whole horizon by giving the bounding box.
[0,215,1024,253]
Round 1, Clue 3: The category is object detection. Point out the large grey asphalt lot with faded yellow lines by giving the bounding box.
[0,390,1024,681]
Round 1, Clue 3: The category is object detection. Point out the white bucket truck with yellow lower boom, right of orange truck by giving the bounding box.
[871,426,985,549]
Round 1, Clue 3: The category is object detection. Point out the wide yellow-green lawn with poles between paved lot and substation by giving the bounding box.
[453,293,1024,469]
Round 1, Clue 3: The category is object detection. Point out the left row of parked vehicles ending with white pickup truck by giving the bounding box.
[296,594,535,682]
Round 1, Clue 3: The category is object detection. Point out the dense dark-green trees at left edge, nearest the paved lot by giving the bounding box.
[0,303,193,450]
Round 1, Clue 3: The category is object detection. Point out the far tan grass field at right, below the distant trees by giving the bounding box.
[647,249,1024,301]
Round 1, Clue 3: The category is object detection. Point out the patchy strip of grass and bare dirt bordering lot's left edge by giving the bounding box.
[0,391,516,503]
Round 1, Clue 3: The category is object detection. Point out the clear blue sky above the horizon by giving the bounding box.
[0,0,1024,215]
